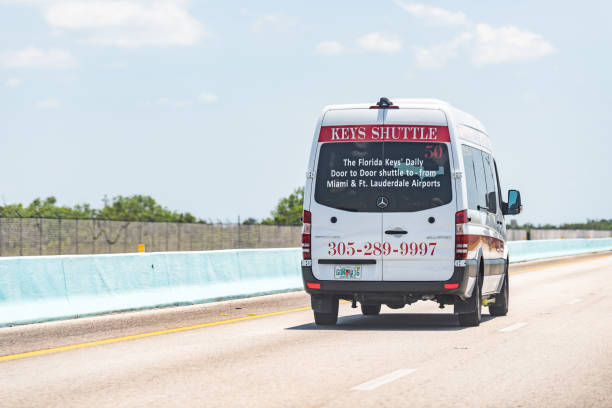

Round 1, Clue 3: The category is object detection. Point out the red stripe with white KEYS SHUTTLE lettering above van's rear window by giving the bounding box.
[319,125,450,142]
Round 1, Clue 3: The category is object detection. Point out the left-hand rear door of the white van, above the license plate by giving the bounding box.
[310,109,383,281]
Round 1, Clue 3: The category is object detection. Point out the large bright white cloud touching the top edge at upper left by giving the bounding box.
[44,0,206,47]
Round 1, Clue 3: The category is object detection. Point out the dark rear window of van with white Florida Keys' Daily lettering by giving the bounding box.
[315,142,452,212]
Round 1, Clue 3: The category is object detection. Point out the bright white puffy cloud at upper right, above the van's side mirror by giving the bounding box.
[472,24,555,66]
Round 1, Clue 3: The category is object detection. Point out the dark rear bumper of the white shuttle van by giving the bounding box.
[302,260,478,298]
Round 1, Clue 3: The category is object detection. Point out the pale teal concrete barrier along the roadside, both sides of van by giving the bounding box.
[0,238,612,326]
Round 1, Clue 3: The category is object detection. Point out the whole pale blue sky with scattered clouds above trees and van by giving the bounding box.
[0,0,612,223]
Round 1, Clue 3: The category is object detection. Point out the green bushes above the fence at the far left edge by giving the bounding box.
[0,195,205,223]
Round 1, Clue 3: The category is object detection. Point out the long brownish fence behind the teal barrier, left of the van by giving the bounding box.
[0,218,301,256]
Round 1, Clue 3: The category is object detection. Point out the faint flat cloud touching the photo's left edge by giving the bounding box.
[0,47,76,68]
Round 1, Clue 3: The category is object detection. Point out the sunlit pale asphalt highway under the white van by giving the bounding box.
[0,253,612,408]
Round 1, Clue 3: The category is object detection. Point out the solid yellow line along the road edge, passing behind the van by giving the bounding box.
[0,254,612,362]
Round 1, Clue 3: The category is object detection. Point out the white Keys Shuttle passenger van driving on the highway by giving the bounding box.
[302,98,522,326]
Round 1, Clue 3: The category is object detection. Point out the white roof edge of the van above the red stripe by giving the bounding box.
[323,98,488,136]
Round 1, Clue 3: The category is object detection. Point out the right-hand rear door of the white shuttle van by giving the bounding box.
[382,109,456,281]
